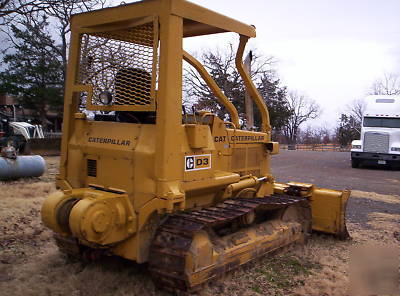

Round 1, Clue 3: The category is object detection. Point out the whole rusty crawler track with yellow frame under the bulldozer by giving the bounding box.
[149,195,311,292]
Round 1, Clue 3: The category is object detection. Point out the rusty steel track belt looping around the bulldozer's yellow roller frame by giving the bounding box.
[149,195,311,292]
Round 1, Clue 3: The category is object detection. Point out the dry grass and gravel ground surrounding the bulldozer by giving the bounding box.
[0,151,400,296]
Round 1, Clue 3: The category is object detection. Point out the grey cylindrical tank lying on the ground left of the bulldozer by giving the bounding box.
[0,155,46,181]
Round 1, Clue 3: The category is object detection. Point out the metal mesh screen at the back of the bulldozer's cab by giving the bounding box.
[77,22,157,110]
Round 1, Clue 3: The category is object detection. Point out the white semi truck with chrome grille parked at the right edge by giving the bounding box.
[351,95,400,168]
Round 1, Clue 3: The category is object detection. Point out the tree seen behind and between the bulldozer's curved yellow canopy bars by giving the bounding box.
[184,43,291,135]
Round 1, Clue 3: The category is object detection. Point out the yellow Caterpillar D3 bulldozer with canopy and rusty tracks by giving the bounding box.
[41,0,350,291]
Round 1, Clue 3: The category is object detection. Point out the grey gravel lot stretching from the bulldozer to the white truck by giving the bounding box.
[271,150,400,195]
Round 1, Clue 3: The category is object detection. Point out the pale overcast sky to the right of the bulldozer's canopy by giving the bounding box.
[184,0,400,127]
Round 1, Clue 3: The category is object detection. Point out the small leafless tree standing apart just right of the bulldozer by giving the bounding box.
[284,91,320,144]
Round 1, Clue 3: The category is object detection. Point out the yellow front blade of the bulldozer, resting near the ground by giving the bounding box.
[274,182,350,239]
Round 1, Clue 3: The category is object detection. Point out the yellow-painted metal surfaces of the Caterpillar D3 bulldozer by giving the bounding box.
[42,0,349,281]
